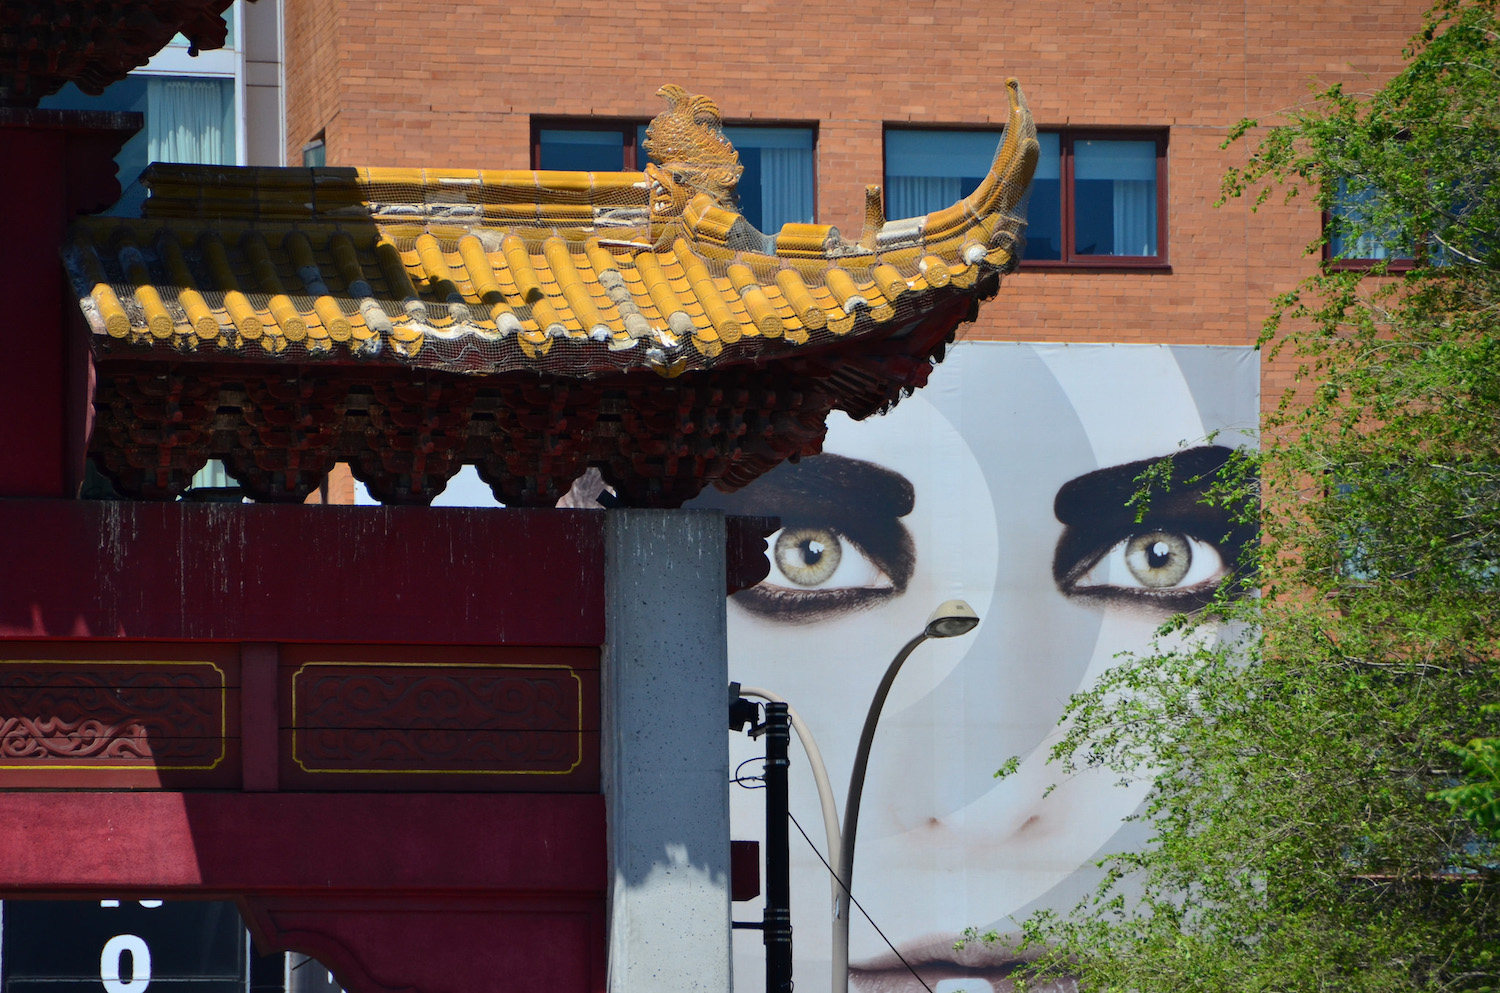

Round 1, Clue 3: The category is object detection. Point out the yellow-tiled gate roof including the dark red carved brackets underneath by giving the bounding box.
[65,83,1038,507]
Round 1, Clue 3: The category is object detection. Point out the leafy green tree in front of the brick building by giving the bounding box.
[1008,0,1500,993]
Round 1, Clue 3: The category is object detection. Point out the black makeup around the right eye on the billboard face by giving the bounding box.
[1052,446,1256,612]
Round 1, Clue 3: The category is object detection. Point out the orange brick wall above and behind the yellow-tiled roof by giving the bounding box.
[287,0,1425,399]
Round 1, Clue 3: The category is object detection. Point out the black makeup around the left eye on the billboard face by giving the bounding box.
[687,453,917,621]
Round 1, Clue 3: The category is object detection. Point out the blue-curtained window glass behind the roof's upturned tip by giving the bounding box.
[885,128,1167,267]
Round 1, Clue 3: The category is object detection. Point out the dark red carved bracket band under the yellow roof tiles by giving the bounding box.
[90,357,840,507]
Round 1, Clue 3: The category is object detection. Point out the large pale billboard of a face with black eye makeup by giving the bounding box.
[698,342,1260,993]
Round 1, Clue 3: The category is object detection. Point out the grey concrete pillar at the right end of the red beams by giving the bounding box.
[602,510,731,993]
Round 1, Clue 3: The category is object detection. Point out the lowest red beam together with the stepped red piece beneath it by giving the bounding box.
[0,792,608,993]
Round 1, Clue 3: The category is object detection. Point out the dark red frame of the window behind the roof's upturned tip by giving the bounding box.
[881,122,1172,273]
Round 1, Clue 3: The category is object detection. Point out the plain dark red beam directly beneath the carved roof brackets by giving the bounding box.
[0,501,605,645]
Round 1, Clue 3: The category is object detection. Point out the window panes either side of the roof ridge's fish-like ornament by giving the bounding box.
[531,120,818,231]
